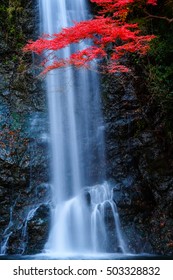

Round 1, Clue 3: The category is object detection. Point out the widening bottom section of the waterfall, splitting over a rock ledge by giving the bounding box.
[45,182,126,255]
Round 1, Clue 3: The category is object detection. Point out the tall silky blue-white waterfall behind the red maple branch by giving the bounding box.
[40,0,125,254]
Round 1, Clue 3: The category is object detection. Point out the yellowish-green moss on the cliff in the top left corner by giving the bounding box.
[0,0,32,79]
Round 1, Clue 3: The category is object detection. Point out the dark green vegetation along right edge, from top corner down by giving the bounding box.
[139,0,173,140]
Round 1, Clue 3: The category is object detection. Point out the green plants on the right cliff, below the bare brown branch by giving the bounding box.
[146,23,173,141]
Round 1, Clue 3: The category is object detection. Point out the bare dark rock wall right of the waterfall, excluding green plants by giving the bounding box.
[102,73,173,255]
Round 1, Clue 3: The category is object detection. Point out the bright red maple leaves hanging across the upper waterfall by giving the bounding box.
[24,0,157,73]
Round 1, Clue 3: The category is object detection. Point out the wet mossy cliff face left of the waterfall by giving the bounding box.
[0,1,49,254]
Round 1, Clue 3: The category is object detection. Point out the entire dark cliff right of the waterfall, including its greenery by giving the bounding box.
[103,0,173,255]
